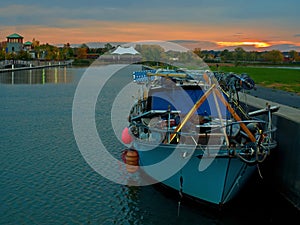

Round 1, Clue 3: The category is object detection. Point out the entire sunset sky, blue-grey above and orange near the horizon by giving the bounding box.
[0,0,300,51]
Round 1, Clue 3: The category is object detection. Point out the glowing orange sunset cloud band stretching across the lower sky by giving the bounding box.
[0,19,300,49]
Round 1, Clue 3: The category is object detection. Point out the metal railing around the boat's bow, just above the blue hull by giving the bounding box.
[131,120,277,164]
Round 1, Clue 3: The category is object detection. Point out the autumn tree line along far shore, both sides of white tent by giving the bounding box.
[0,39,300,65]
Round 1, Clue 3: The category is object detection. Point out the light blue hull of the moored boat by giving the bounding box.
[135,143,256,205]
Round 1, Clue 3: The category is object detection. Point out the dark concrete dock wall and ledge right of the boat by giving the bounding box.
[241,90,300,211]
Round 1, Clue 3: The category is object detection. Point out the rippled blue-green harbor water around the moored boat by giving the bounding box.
[0,67,300,225]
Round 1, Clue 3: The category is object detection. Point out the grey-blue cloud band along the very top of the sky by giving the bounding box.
[0,0,300,25]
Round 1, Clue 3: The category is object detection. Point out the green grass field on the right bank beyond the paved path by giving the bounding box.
[210,66,300,95]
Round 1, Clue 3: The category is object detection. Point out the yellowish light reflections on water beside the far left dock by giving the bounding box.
[0,67,74,85]
